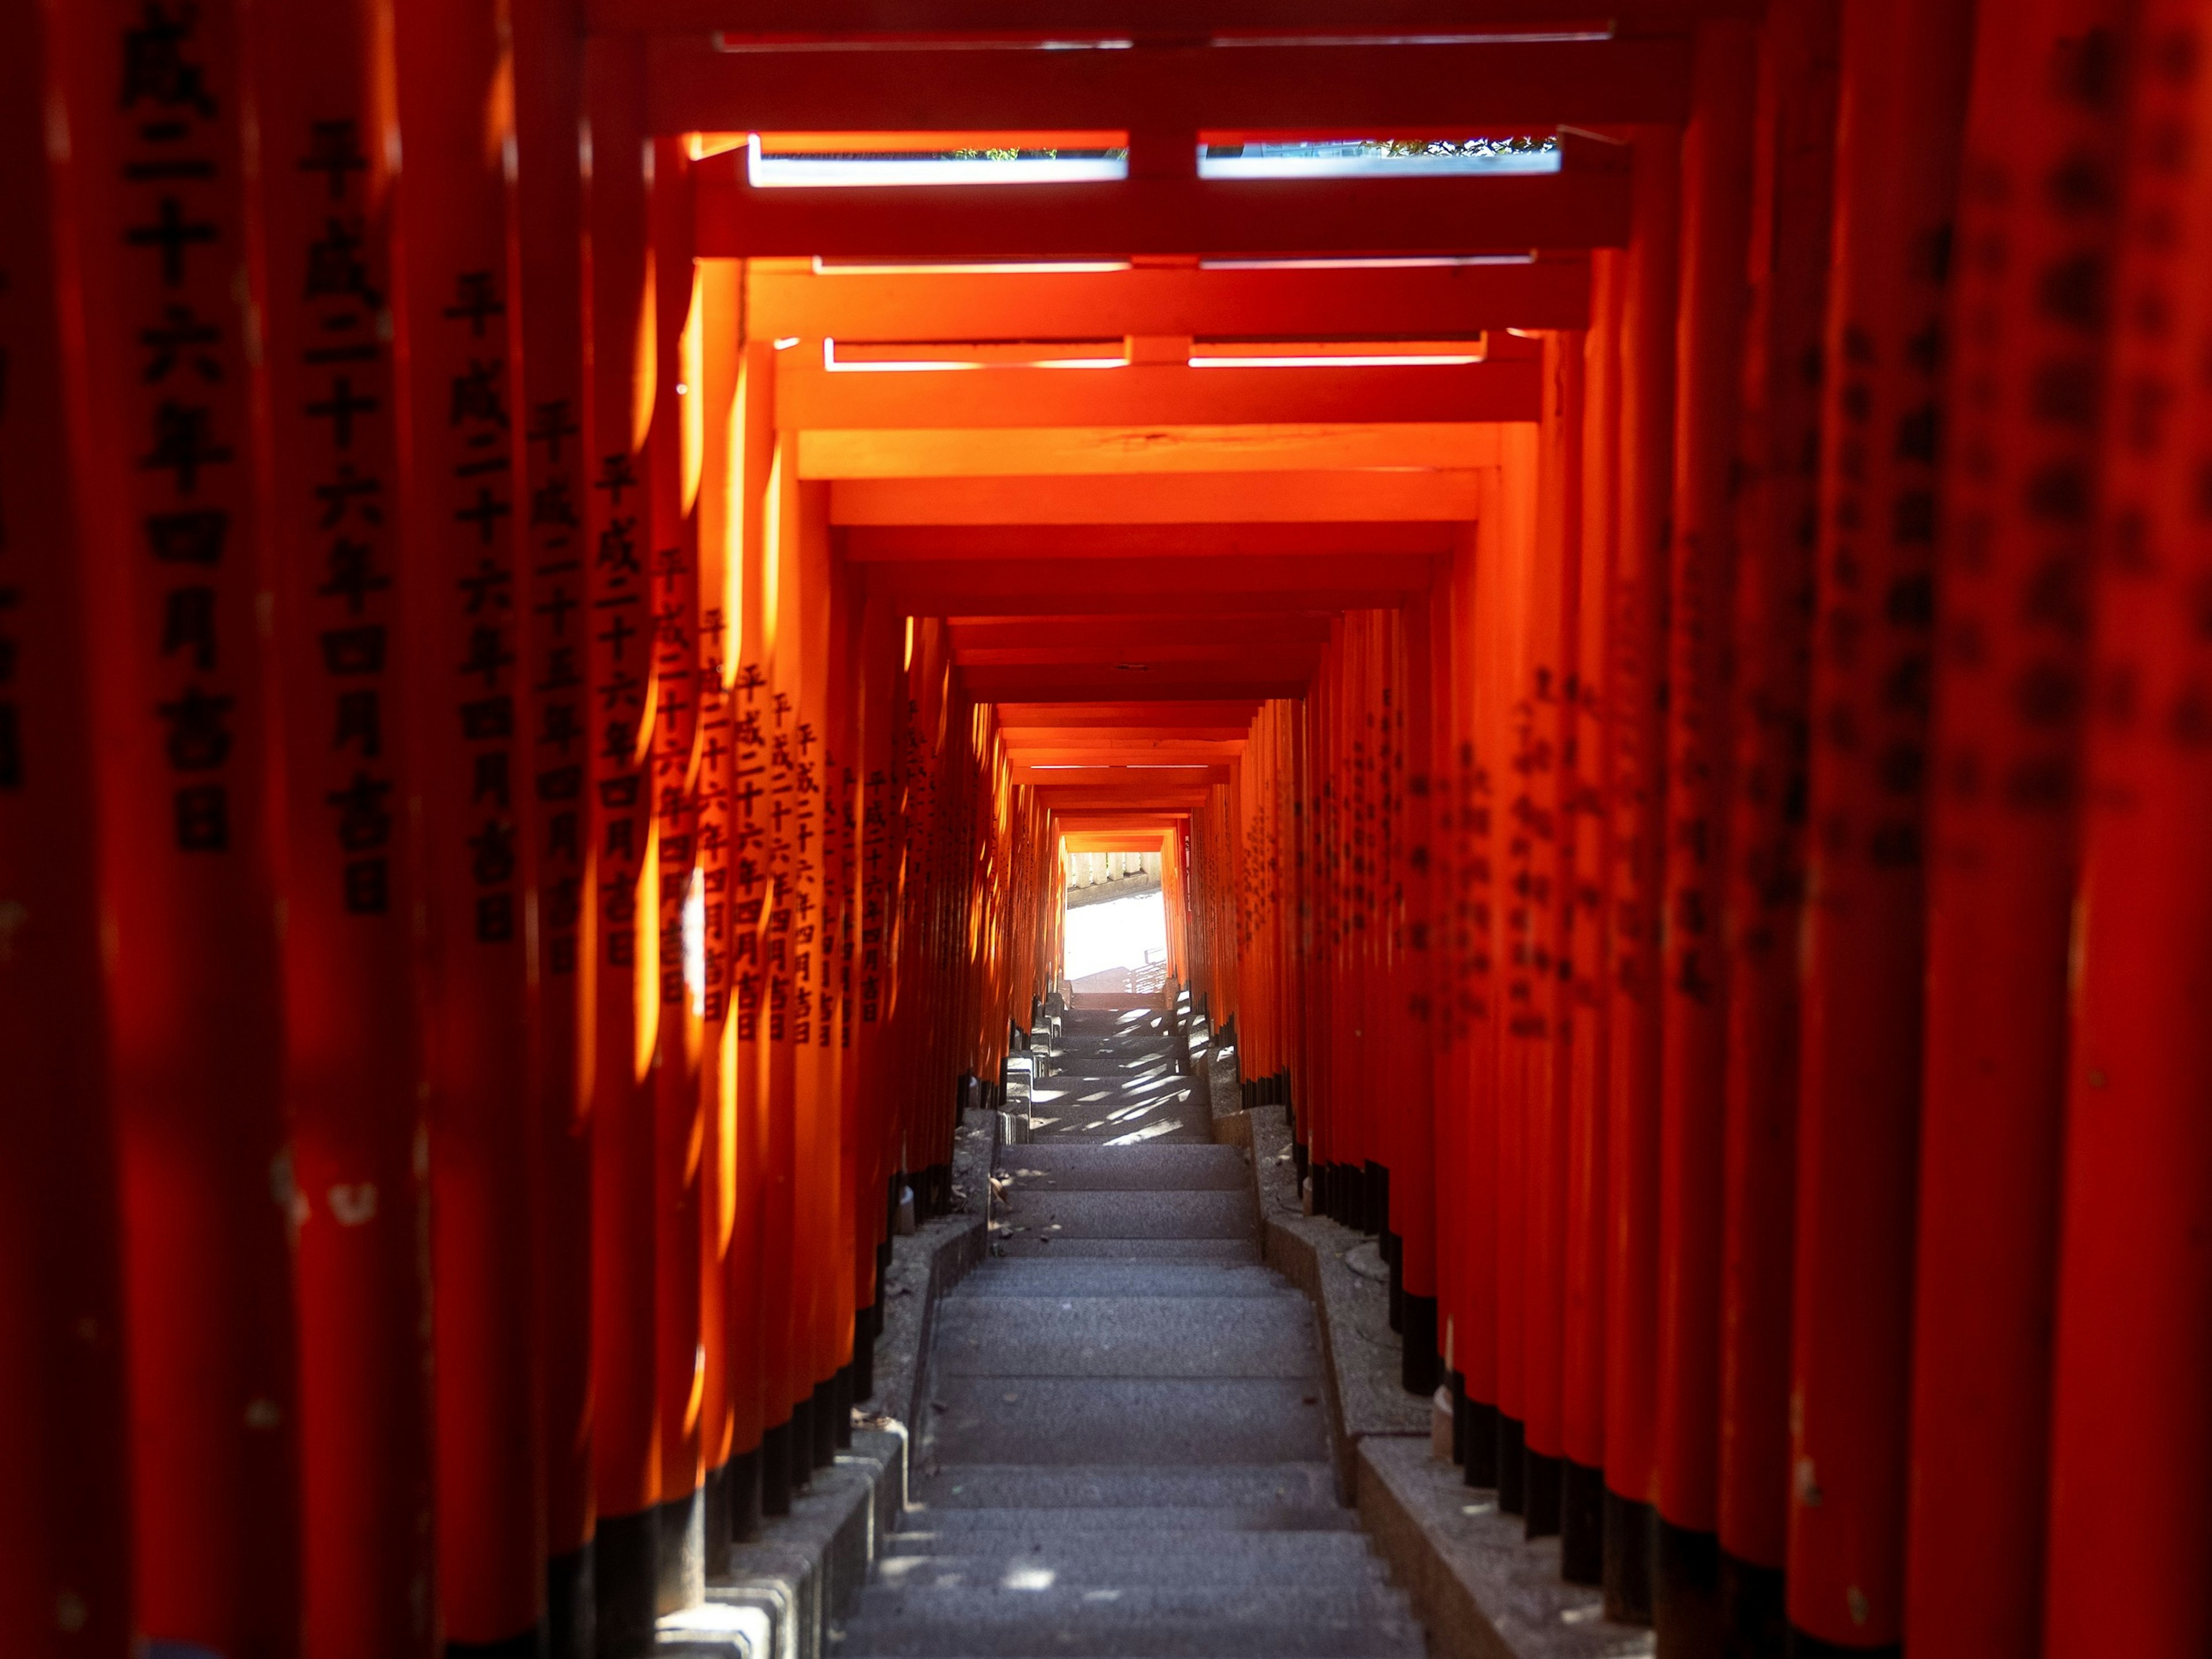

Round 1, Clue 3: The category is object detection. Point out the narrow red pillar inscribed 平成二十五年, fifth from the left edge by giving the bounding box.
[506,0,597,1659]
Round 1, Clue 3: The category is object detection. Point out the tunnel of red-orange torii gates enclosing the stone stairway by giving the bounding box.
[0,0,2212,1659]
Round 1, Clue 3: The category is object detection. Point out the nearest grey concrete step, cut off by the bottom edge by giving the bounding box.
[836,1590,1422,1659]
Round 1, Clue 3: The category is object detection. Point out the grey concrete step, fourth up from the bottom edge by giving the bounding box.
[927,1376,1330,1469]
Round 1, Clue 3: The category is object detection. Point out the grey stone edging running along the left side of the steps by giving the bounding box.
[655,1111,998,1659]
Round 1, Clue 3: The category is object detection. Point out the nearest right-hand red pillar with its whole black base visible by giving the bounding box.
[1606,132,1679,1624]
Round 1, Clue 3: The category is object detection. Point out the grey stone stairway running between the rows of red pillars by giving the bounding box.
[838,1006,1425,1659]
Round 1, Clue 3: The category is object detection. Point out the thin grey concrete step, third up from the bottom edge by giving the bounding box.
[909,1462,1358,1531]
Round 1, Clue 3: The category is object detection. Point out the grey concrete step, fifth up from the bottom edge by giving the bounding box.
[935,1296,1320,1380]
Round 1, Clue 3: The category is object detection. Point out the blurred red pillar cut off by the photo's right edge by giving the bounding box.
[2035,0,2212,1659]
